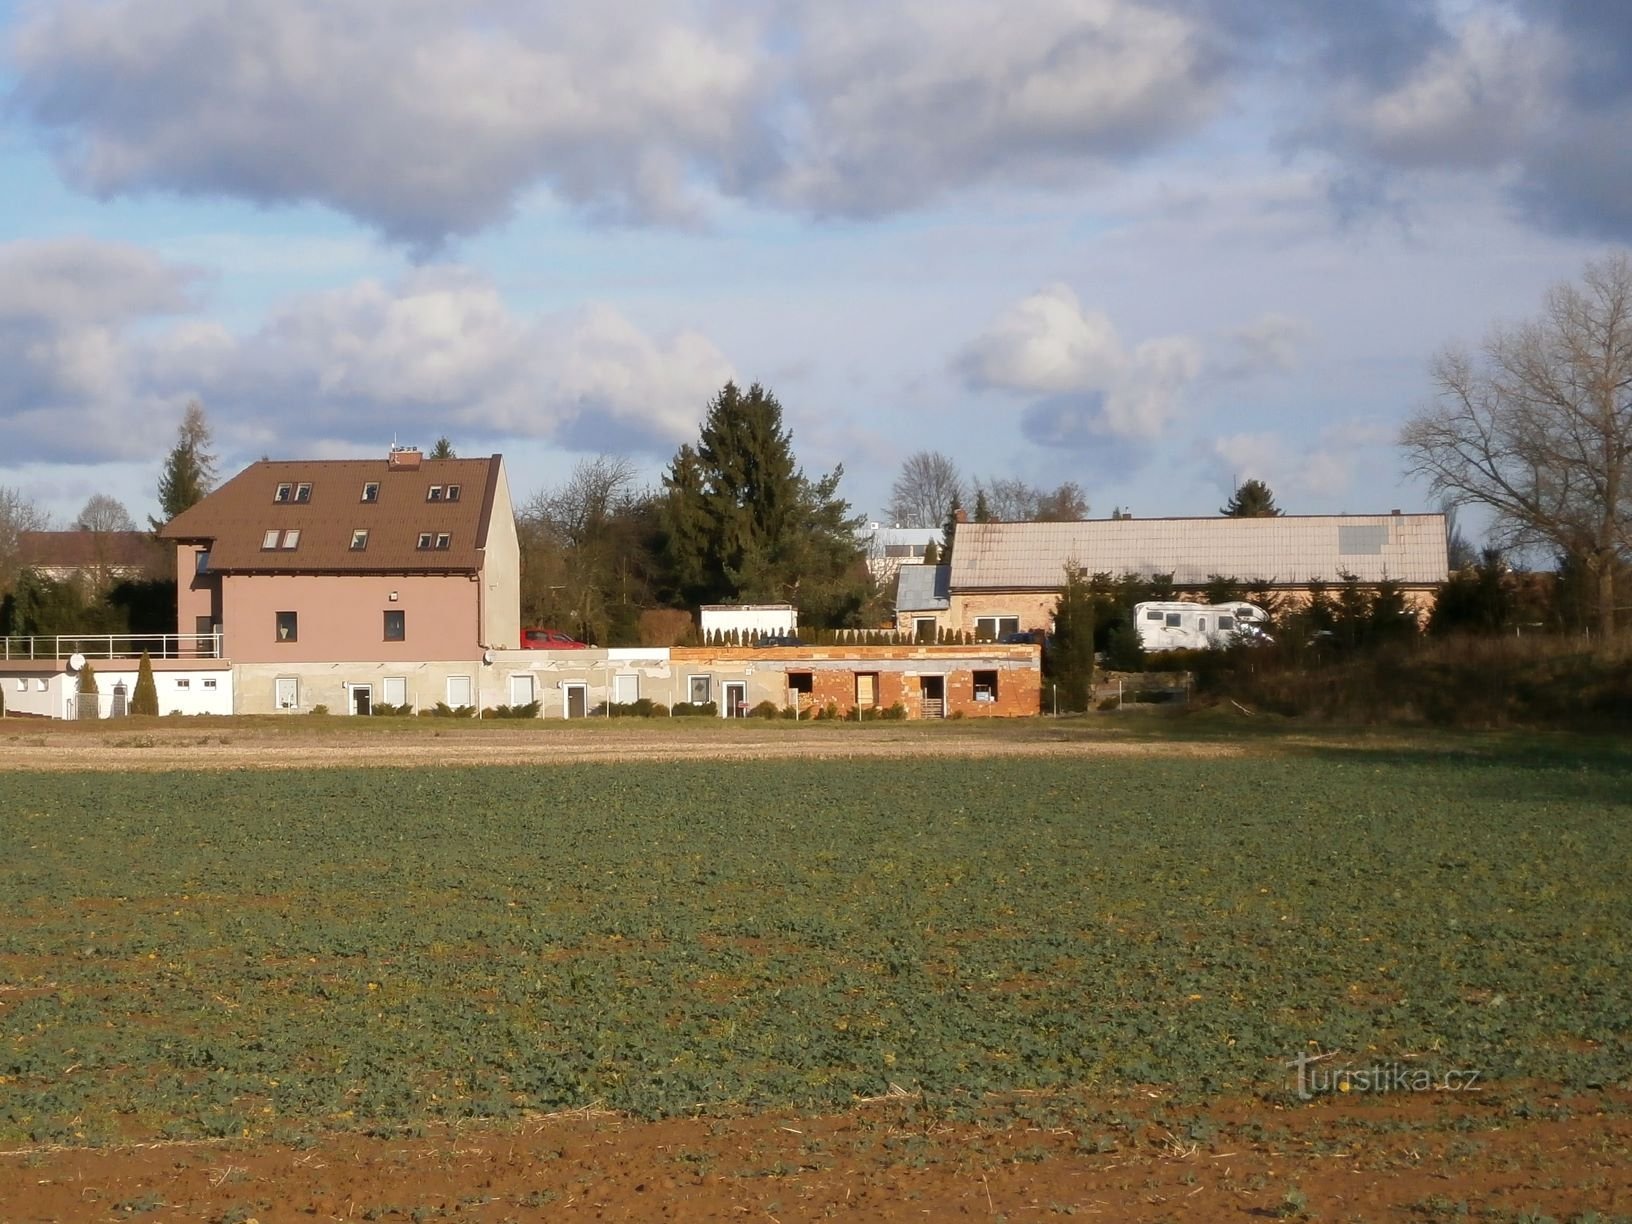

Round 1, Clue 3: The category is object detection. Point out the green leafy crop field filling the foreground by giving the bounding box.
[0,741,1632,1142]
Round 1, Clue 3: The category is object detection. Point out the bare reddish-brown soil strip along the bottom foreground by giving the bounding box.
[0,1092,1632,1224]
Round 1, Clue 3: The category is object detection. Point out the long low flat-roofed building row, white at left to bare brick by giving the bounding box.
[0,645,1043,718]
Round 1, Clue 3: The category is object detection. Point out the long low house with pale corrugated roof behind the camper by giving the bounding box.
[896,512,1449,638]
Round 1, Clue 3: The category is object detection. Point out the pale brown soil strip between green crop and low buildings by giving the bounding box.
[0,718,1245,772]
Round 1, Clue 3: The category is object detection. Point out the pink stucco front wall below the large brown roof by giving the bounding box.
[223,574,485,663]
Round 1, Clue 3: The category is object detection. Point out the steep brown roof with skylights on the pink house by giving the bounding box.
[160,455,504,574]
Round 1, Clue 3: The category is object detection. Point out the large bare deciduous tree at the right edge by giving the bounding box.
[1400,251,1632,635]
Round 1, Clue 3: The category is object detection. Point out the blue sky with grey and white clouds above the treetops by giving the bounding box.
[0,0,1632,526]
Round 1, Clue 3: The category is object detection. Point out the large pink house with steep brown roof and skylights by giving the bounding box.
[160,449,521,713]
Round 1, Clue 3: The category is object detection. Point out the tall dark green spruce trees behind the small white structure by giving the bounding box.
[663,382,871,625]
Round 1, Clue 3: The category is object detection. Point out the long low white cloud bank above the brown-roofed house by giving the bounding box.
[0,243,734,463]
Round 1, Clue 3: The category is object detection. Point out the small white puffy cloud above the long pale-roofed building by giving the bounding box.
[956,284,1201,446]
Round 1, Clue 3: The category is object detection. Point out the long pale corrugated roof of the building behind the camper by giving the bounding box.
[951,514,1446,591]
